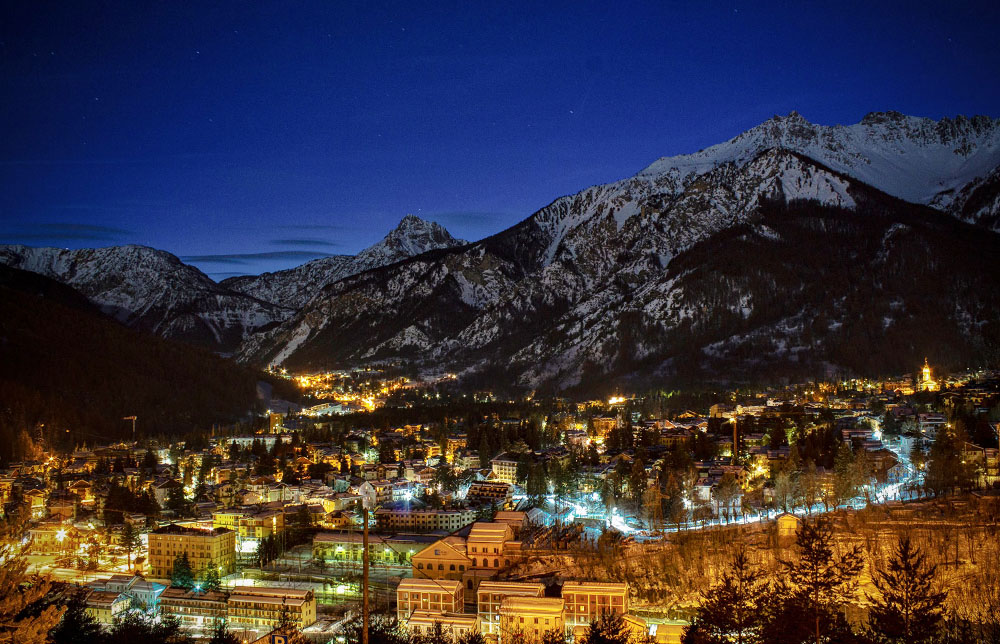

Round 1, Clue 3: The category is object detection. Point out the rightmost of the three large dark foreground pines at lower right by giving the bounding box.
[868,537,946,643]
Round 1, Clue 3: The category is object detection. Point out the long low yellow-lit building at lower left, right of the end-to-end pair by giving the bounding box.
[228,586,316,631]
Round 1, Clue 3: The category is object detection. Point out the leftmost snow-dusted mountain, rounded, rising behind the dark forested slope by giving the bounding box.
[0,245,288,351]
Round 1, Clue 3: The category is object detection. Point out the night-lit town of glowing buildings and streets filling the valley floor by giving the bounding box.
[0,362,1000,644]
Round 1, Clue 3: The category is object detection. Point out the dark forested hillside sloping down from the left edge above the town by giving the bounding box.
[0,267,297,462]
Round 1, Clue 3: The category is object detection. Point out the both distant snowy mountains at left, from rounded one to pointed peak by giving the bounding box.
[0,216,465,353]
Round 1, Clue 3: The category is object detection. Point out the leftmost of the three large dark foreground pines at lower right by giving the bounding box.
[685,548,769,644]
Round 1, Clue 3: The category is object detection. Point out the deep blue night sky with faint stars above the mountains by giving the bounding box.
[0,1,1000,278]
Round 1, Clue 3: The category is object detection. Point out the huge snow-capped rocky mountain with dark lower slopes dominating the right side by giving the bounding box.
[240,112,1000,386]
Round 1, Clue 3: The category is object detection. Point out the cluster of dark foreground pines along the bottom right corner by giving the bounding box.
[683,520,1000,644]
